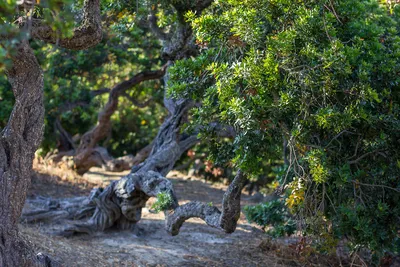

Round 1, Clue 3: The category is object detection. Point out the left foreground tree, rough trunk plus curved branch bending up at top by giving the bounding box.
[0,0,102,266]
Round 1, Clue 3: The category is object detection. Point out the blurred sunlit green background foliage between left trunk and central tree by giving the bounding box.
[0,1,166,173]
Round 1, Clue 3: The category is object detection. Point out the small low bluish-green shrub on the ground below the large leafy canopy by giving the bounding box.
[244,200,296,237]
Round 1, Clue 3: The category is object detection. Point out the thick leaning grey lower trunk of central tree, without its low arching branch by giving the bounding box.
[56,68,198,236]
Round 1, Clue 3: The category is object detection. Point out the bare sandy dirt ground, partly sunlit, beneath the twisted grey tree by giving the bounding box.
[21,168,333,267]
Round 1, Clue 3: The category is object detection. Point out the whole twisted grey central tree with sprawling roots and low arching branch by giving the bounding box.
[24,0,245,241]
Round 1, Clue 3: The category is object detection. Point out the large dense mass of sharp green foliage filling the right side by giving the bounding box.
[170,0,400,264]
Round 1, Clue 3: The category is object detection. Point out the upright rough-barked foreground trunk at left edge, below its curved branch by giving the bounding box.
[0,42,48,267]
